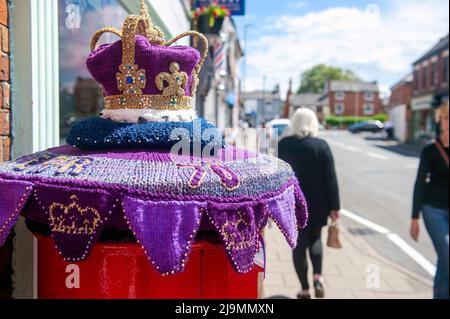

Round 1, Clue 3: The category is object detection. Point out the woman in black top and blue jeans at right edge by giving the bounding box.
[411,103,449,299]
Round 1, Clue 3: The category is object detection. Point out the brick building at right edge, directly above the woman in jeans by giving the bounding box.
[411,35,449,143]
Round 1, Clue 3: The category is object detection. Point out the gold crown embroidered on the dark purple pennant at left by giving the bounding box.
[49,195,101,235]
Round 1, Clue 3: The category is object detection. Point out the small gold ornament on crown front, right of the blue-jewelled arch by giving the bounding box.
[155,62,188,97]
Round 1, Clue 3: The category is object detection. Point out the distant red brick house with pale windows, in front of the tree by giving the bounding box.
[321,80,382,116]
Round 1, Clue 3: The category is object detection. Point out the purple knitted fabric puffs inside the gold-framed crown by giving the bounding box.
[86,35,200,96]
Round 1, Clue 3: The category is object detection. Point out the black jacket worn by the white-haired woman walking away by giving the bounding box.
[278,136,340,227]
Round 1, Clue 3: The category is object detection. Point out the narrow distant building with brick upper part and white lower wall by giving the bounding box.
[388,74,413,142]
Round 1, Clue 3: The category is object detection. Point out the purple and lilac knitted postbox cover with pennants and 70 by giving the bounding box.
[0,146,308,274]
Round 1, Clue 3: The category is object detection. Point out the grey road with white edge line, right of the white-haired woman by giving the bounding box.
[321,131,436,279]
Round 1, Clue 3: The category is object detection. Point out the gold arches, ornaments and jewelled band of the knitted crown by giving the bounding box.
[91,0,208,110]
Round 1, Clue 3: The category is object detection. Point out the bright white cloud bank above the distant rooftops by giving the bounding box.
[248,0,449,96]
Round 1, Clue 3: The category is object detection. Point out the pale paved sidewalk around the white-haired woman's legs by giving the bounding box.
[263,220,432,299]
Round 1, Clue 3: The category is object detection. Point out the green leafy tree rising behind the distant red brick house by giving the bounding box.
[297,64,360,93]
